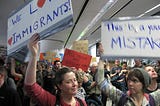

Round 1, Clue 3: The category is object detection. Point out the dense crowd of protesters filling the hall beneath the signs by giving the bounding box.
[0,33,160,106]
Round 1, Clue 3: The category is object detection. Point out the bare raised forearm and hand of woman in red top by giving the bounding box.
[24,33,39,85]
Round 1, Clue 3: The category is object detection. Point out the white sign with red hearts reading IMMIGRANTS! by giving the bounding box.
[7,0,73,61]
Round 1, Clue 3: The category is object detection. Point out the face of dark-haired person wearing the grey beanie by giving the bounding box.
[127,77,143,94]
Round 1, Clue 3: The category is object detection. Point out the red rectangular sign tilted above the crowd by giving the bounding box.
[62,49,92,71]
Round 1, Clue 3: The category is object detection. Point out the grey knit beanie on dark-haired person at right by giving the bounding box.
[133,68,151,88]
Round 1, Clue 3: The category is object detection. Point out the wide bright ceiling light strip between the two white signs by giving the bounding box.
[76,0,118,41]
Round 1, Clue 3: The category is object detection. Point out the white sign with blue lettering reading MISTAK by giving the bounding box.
[101,17,160,58]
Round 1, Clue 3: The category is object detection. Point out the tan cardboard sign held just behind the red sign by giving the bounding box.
[72,40,88,54]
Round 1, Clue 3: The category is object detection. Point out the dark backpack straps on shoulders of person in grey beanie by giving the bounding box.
[118,94,156,106]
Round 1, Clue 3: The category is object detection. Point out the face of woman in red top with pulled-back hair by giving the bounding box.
[59,72,78,95]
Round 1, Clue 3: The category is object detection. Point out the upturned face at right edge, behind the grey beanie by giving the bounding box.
[145,66,158,79]
